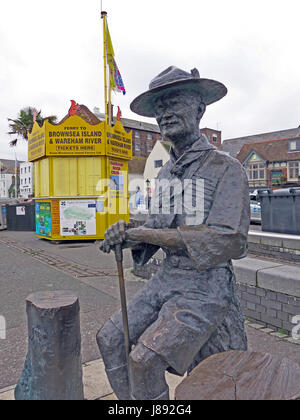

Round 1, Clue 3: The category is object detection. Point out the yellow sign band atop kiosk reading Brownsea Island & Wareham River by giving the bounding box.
[28,115,132,162]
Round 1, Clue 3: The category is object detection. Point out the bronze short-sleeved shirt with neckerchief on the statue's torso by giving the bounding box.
[133,136,250,270]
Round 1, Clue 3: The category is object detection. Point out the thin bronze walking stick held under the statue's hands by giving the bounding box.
[115,245,131,394]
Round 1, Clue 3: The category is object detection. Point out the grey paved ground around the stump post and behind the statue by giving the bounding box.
[0,231,300,396]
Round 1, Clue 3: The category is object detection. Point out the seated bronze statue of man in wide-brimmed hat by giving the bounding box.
[97,67,249,399]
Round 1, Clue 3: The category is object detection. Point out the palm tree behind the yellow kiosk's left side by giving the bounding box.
[8,106,56,147]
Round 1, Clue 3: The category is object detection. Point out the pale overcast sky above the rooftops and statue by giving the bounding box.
[0,0,300,159]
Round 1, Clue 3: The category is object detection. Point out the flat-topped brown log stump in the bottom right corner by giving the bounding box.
[175,351,300,400]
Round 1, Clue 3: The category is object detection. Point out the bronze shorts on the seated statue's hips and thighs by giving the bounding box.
[111,257,247,375]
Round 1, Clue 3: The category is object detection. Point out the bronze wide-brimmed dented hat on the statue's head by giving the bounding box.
[130,66,227,117]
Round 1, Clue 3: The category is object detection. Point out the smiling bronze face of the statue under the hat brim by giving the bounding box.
[155,92,202,141]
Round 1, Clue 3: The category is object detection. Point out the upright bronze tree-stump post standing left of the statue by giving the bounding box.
[15,291,84,400]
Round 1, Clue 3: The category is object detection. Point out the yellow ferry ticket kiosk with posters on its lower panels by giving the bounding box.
[28,111,132,241]
